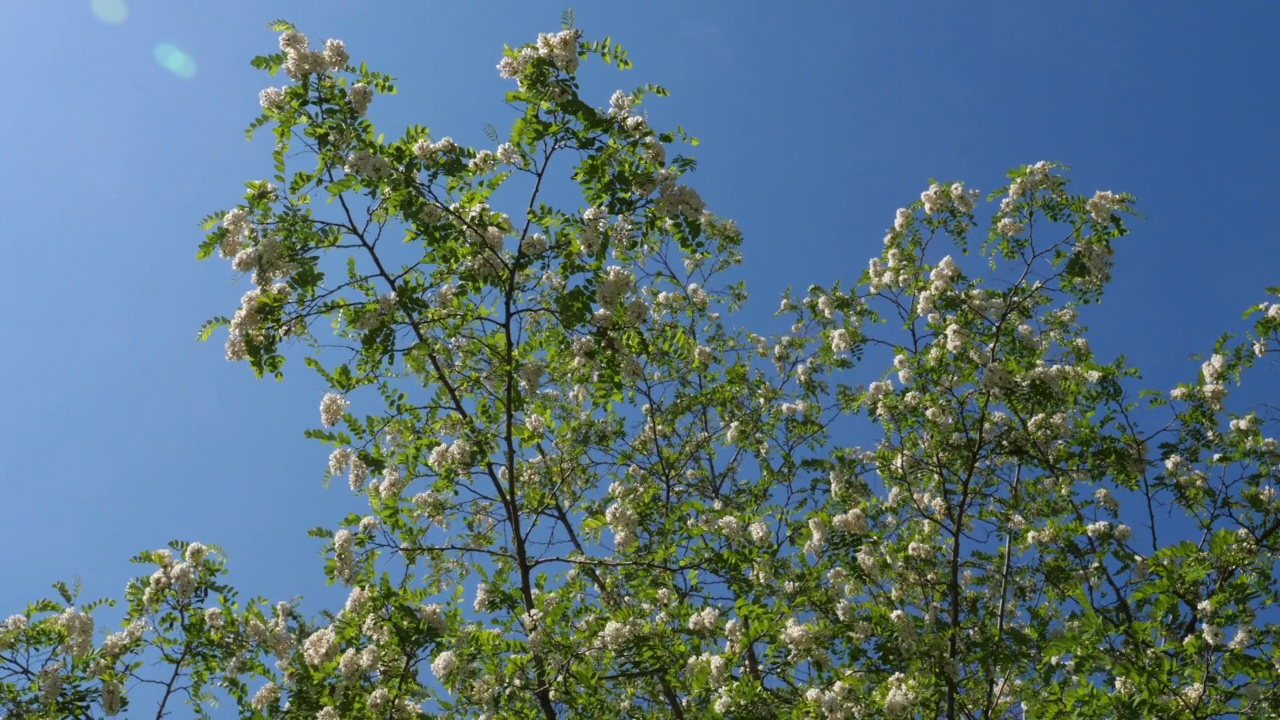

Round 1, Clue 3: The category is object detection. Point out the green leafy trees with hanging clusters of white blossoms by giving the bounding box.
[0,18,1280,719]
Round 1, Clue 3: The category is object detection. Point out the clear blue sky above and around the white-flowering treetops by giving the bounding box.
[0,0,1280,625]
